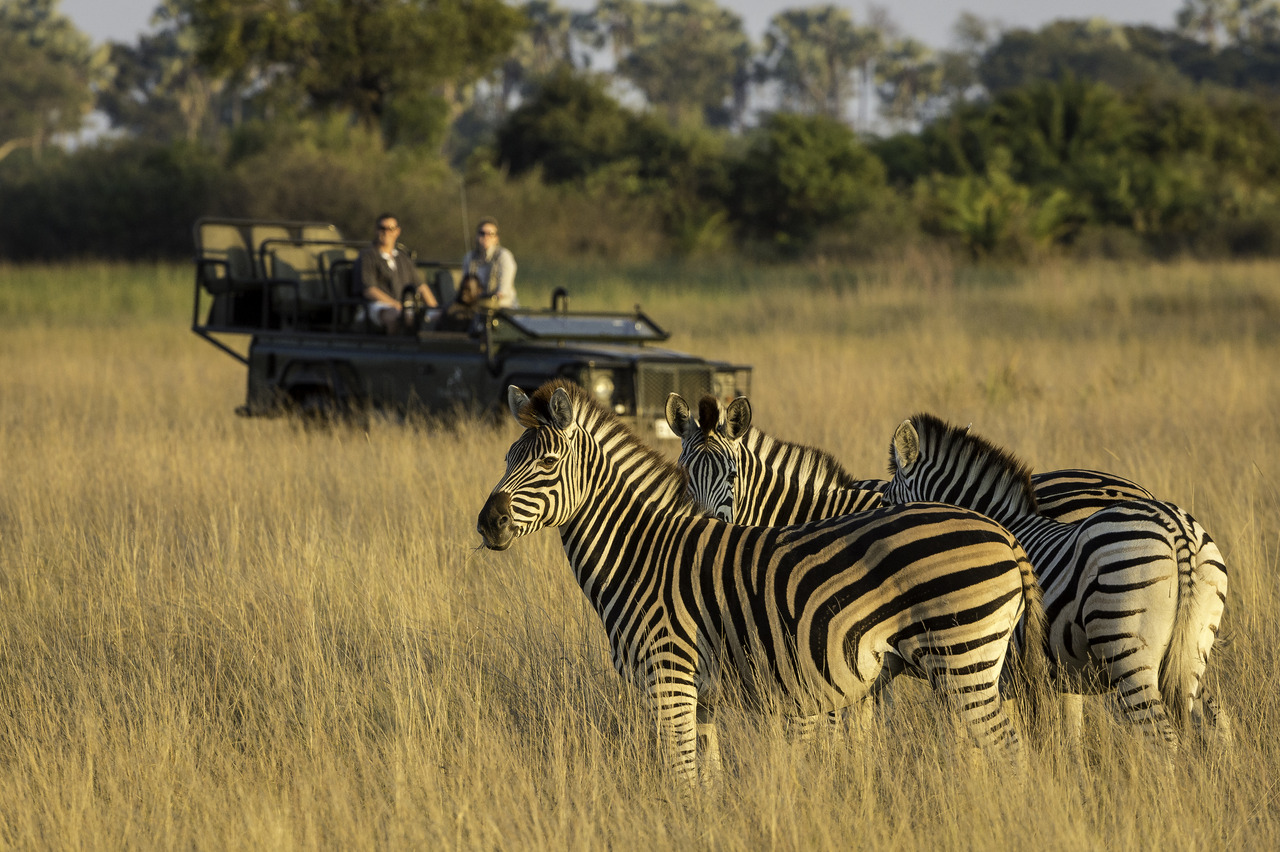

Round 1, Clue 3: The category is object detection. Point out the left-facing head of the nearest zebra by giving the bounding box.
[476,383,582,550]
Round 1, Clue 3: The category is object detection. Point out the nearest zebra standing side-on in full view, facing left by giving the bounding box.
[476,380,1048,785]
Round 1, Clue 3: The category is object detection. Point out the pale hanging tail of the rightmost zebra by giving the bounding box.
[1160,518,1217,730]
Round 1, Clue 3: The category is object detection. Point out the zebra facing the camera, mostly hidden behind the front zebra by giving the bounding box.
[666,394,1155,527]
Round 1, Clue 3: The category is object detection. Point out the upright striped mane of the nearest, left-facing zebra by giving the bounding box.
[517,379,704,514]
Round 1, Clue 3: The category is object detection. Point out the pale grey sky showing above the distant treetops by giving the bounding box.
[61,0,1185,47]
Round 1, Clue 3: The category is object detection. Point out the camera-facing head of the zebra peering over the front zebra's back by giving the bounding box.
[667,394,751,522]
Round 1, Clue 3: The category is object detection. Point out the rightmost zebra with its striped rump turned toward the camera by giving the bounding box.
[884,414,1231,751]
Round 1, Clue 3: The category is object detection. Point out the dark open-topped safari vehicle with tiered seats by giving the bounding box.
[192,219,751,436]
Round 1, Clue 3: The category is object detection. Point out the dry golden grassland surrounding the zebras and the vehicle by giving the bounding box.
[0,257,1280,852]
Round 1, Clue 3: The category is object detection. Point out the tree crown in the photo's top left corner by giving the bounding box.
[0,0,105,160]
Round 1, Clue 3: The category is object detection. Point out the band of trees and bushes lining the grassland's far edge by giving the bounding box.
[12,0,1280,257]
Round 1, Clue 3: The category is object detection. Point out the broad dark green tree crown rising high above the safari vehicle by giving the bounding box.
[188,0,525,142]
